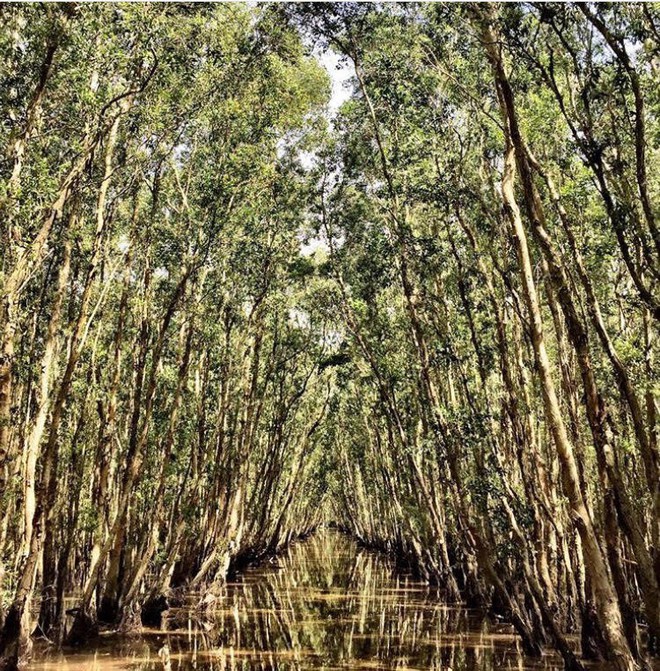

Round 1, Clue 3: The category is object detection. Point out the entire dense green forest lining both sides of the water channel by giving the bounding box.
[0,3,660,671]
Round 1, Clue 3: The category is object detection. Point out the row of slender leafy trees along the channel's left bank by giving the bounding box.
[0,4,329,669]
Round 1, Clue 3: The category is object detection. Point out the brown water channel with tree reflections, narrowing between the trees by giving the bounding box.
[29,530,562,671]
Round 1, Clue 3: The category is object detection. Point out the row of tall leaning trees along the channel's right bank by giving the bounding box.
[293,3,660,671]
